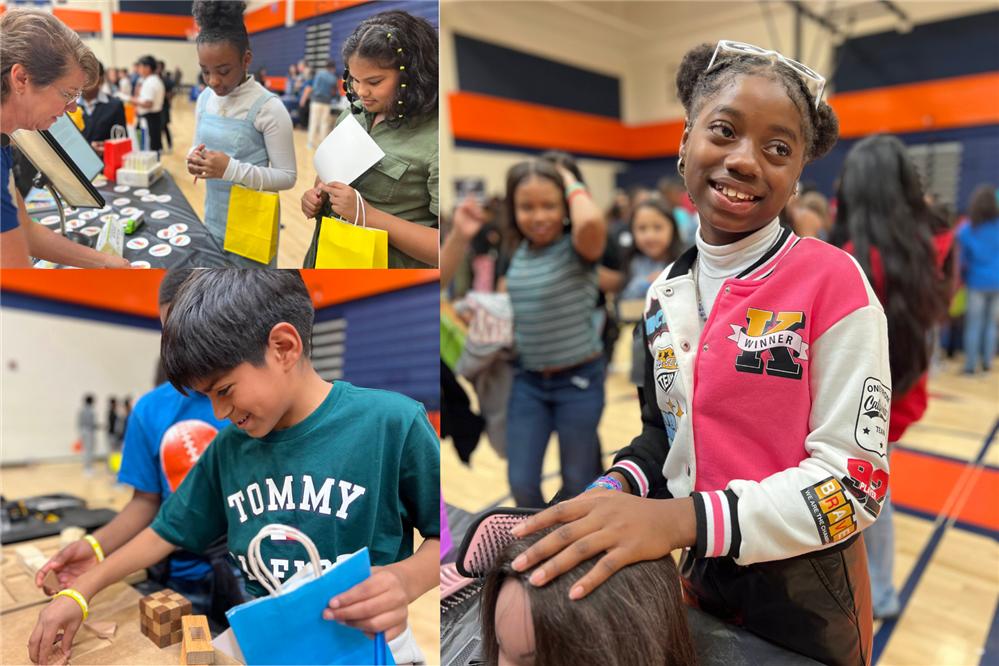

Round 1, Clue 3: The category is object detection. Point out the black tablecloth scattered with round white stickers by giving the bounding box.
[30,171,232,268]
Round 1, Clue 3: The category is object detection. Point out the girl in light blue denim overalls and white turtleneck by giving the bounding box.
[187,0,297,268]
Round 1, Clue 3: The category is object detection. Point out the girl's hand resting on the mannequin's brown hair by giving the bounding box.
[511,488,697,599]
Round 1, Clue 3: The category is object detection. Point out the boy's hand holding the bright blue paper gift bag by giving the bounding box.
[323,567,409,641]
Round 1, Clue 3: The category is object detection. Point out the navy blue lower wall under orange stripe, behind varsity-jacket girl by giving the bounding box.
[617,125,999,213]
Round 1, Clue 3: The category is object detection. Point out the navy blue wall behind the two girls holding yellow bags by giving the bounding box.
[250,0,440,81]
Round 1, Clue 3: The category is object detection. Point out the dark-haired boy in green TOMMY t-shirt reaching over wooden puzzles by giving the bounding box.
[29,270,440,663]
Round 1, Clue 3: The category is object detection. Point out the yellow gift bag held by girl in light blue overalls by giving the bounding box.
[224,185,281,264]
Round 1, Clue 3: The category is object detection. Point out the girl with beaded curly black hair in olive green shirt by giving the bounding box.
[302,9,440,268]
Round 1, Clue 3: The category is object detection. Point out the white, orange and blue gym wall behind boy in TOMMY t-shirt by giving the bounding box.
[0,271,440,465]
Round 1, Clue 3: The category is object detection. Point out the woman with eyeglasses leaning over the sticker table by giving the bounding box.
[0,9,131,268]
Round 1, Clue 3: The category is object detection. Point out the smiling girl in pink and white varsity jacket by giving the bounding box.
[514,42,891,665]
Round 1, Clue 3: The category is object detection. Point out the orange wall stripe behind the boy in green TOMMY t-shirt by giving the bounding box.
[0,269,440,317]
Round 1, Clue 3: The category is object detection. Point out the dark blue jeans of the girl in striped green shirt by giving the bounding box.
[506,356,604,507]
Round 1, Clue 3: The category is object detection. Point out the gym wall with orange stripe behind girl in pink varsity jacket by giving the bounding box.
[441,1,999,210]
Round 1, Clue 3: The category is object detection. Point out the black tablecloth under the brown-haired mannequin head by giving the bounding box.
[441,504,821,666]
